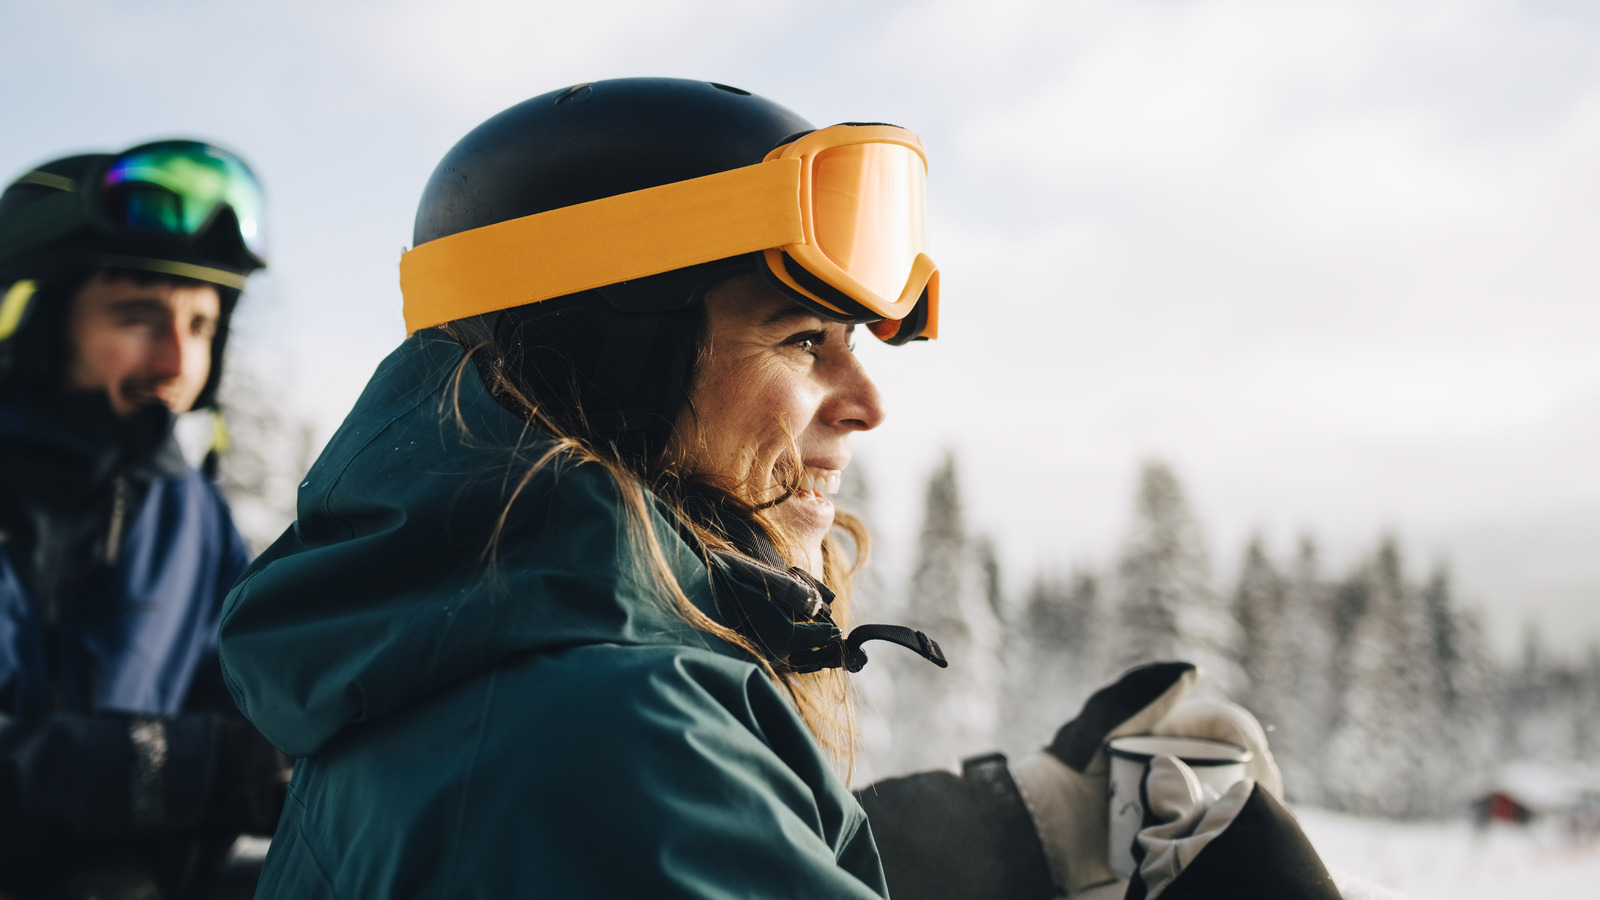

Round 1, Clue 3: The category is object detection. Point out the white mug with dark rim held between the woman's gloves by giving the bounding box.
[1106,735,1251,878]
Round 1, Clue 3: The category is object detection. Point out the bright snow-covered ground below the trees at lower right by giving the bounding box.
[1294,809,1600,900]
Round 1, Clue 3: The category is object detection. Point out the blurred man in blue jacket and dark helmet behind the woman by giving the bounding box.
[0,141,286,900]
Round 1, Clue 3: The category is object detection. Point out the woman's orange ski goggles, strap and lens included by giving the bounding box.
[400,125,939,344]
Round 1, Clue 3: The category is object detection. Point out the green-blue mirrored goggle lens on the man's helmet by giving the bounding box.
[101,141,267,259]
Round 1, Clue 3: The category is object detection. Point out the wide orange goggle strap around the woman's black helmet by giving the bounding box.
[400,159,805,333]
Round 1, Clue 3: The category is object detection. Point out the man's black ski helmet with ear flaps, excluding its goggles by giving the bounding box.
[0,139,266,408]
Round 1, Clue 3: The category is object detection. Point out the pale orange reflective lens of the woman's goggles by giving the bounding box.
[811,143,928,303]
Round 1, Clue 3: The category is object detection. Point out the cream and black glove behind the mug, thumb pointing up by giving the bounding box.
[1011,661,1283,897]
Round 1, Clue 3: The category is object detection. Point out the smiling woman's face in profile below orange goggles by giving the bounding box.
[669,272,883,575]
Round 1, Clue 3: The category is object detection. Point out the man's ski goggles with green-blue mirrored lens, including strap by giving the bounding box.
[0,141,267,287]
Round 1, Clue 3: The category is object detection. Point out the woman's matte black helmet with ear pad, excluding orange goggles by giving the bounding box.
[413,78,813,461]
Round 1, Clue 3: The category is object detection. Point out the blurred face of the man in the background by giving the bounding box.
[66,272,222,418]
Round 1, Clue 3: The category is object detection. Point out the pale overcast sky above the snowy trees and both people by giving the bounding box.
[0,0,1600,649]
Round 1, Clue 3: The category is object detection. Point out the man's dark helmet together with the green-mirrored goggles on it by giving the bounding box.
[0,141,266,408]
